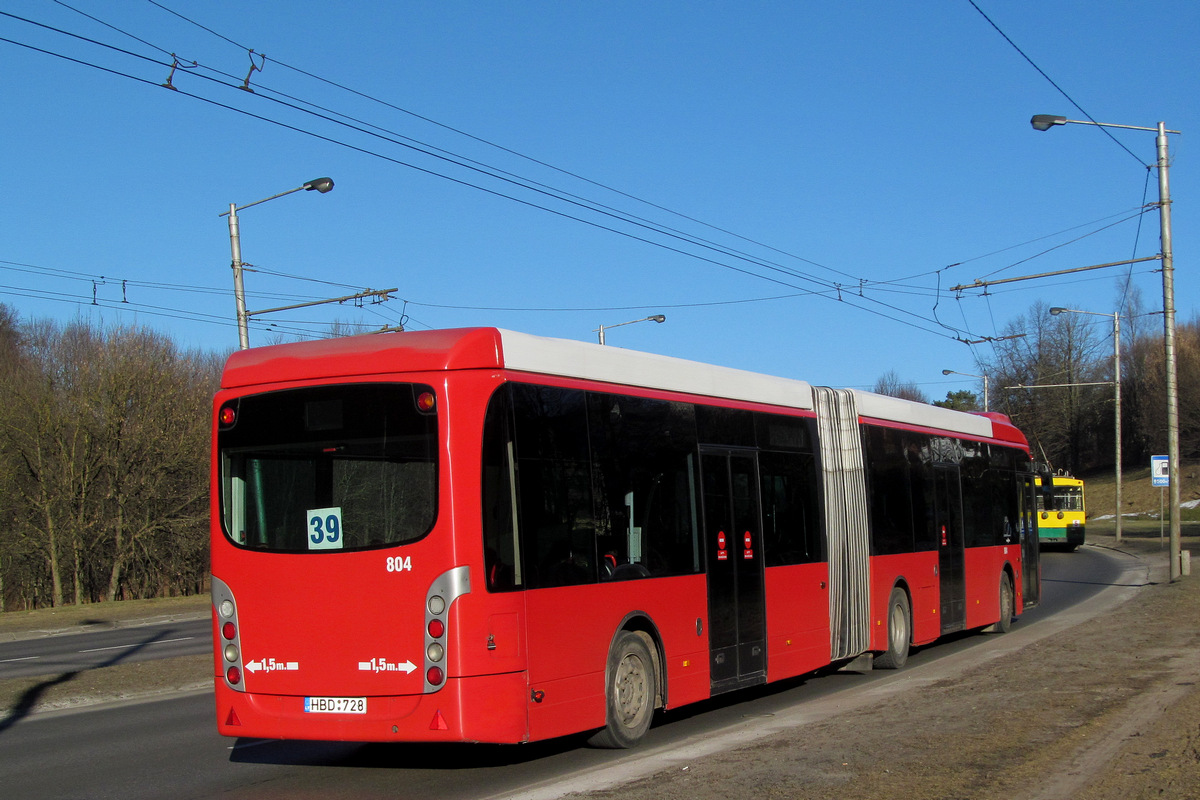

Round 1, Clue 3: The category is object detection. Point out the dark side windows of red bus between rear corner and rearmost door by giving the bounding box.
[482,384,703,590]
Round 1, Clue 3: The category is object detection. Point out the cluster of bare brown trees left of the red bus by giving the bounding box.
[0,314,220,606]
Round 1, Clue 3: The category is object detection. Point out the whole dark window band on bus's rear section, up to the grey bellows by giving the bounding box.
[482,384,824,591]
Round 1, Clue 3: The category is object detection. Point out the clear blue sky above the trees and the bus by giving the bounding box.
[0,0,1200,399]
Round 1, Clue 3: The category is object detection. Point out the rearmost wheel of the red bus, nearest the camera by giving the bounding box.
[588,631,658,748]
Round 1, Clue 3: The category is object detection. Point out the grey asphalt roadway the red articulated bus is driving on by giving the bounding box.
[0,548,1128,800]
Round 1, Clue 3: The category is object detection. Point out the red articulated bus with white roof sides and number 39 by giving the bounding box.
[212,329,1039,747]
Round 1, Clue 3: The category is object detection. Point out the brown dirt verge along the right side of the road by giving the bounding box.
[573,535,1200,800]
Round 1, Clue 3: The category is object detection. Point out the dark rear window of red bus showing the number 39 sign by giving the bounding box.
[217,384,438,553]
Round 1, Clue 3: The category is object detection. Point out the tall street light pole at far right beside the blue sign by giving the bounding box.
[1030,114,1183,583]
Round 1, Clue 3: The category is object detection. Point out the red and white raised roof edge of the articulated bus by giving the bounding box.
[221,327,1026,447]
